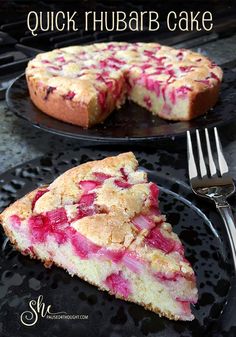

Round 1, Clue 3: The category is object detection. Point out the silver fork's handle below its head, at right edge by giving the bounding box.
[214,198,236,275]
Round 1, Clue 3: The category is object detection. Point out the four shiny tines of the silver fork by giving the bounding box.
[187,127,229,179]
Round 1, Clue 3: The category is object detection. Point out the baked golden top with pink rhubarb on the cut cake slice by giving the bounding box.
[0,152,195,280]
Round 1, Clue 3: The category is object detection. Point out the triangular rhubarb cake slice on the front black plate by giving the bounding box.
[0,152,197,320]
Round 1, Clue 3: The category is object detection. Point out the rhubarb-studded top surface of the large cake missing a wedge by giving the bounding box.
[26,42,222,101]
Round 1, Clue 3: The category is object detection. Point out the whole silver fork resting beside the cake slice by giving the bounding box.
[187,128,236,273]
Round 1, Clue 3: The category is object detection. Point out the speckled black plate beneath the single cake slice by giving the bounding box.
[0,149,233,337]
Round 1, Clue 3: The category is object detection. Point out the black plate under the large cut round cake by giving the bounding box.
[7,70,236,144]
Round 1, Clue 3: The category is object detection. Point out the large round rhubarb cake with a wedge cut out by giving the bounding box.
[26,42,222,128]
